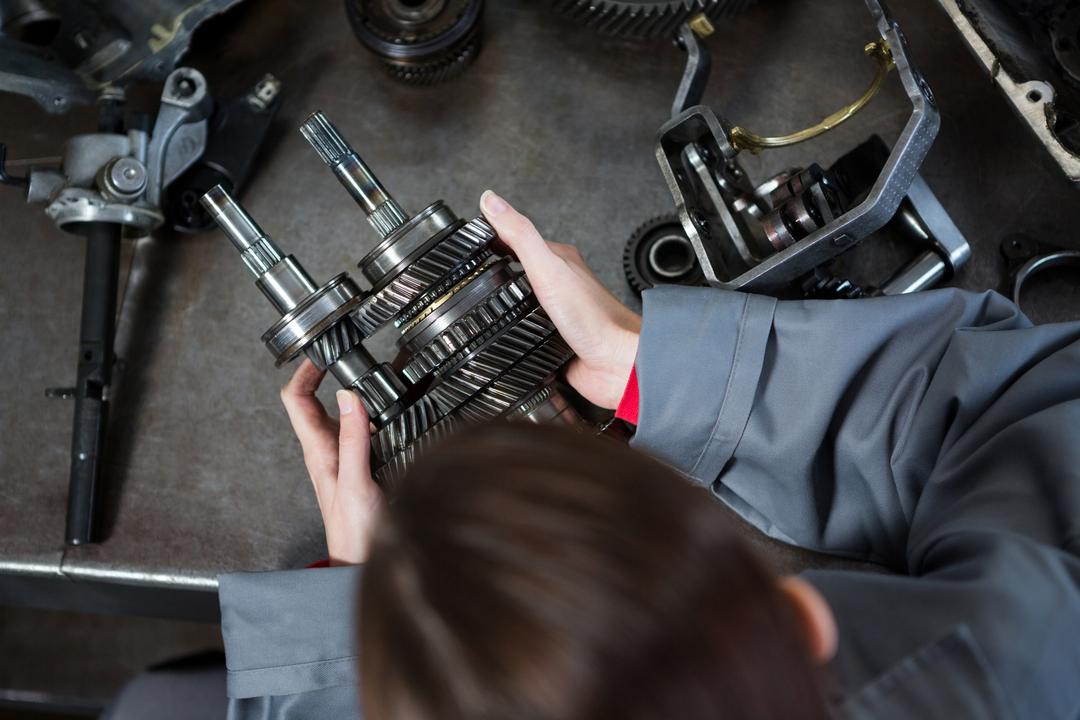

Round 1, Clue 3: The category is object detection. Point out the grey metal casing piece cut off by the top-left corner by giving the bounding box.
[0,0,240,113]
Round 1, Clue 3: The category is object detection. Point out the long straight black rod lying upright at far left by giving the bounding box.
[65,222,121,545]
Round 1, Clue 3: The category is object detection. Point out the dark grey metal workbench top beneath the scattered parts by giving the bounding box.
[0,0,1080,612]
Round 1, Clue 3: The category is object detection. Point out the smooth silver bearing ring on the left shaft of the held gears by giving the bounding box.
[262,273,364,367]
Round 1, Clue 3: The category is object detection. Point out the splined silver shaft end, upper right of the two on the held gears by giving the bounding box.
[300,111,408,237]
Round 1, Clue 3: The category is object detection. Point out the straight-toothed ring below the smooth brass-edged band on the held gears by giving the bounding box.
[403,275,532,383]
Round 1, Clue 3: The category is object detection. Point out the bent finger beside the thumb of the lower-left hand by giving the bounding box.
[281,359,337,499]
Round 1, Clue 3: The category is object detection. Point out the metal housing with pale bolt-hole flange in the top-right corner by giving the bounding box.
[937,0,1080,185]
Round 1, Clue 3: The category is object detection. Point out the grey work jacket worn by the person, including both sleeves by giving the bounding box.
[220,287,1080,720]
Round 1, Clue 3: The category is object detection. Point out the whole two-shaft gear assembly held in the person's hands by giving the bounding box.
[203,112,585,487]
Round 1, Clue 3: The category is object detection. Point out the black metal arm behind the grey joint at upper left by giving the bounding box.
[163,74,281,233]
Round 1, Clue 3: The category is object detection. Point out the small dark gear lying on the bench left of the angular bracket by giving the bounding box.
[622,215,705,295]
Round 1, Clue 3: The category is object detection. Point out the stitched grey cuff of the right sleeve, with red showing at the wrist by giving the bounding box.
[632,287,777,485]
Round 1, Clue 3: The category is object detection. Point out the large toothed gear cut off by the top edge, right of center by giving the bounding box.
[555,0,754,38]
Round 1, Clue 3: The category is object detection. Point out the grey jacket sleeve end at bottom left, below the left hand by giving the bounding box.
[218,567,361,720]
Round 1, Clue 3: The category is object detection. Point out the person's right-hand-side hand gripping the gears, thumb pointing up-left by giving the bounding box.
[481,190,642,409]
